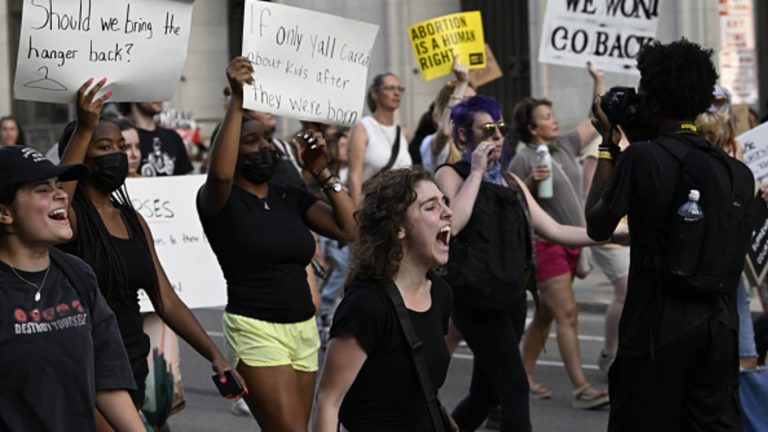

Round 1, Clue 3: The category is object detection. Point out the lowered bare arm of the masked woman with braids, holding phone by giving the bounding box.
[136,212,247,392]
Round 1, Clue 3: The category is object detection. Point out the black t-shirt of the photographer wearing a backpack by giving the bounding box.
[602,133,738,355]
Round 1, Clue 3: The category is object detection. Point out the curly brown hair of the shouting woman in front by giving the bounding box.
[346,166,435,288]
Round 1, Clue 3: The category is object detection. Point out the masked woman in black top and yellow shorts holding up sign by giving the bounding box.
[197,57,357,431]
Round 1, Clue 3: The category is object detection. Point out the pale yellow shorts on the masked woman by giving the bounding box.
[221,312,320,372]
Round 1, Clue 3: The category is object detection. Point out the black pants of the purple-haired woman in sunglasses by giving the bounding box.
[452,299,531,432]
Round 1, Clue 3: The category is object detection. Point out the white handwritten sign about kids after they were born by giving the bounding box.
[243,0,379,125]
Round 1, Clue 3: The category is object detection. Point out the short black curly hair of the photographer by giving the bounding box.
[637,38,717,119]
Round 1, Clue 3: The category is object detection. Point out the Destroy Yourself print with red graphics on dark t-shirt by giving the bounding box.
[13,300,88,335]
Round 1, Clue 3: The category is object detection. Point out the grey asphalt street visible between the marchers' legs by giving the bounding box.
[169,309,608,432]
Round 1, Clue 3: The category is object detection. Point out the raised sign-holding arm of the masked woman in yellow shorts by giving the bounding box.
[198,57,253,217]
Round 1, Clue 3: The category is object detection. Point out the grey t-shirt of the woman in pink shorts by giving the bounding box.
[509,130,586,226]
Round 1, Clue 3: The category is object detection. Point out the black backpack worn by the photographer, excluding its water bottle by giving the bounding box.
[656,132,755,295]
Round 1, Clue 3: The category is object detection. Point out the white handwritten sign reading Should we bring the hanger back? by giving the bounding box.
[14,0,193,103]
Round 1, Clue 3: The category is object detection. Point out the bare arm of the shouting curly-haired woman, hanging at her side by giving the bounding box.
[315,335,368,432]
